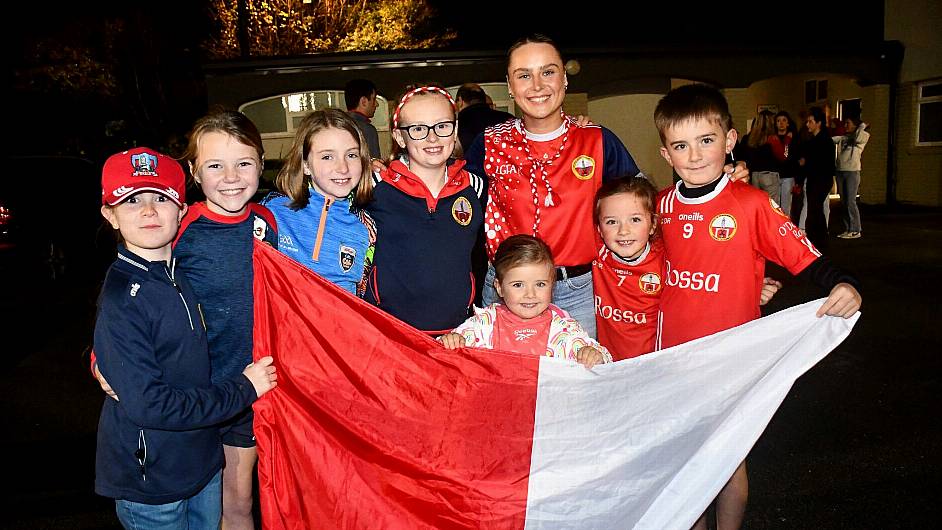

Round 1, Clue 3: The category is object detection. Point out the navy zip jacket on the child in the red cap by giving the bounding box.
[95,247,257,504]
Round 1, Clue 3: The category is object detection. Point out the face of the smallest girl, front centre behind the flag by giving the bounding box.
[494,263,556,320]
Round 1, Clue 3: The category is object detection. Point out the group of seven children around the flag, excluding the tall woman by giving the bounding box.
[95,79,861,528]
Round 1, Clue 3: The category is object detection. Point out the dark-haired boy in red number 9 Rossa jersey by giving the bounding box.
[654,84,861,530]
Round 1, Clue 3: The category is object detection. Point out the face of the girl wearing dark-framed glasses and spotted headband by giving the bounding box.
[393,92,458,177]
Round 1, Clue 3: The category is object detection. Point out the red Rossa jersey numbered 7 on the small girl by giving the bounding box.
[592,240,664,361]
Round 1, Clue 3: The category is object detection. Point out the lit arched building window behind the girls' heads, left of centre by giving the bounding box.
[239,90,389,138]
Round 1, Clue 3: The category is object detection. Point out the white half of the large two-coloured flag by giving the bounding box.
[526,299,860,530]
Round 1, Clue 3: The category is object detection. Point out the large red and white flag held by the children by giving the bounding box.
[255,244,859,530]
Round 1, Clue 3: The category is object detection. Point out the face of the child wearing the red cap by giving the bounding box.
[101,191,186,261]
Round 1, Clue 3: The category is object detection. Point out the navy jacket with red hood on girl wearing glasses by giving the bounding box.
[364,159,487,335]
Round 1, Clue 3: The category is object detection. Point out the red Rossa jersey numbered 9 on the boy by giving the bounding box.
[658,176,821,349]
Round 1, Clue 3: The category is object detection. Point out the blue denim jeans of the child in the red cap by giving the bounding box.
[115,471,222,530]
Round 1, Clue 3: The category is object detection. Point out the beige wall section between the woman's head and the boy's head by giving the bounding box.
[588,94,671,189]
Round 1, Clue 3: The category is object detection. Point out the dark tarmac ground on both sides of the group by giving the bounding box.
[0,202,942,529]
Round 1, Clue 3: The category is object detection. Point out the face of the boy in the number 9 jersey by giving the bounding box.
[661,118,736,188]
